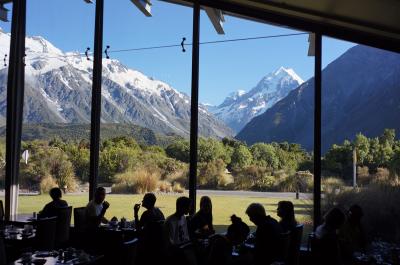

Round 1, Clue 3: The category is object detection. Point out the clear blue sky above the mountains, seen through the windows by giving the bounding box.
[0,0,354,104]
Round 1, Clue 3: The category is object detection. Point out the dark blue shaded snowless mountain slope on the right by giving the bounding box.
[236,45,400,152]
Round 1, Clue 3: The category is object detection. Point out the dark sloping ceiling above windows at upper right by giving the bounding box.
[160,0,400,52]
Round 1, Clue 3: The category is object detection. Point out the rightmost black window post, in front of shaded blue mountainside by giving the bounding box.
[314,33,322,227]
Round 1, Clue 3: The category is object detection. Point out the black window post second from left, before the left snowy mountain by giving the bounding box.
[89,0,104,200]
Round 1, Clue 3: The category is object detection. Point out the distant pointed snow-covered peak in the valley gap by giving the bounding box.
[208,67,304,132]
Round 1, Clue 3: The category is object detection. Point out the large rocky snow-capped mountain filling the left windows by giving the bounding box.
[0,31,232,137]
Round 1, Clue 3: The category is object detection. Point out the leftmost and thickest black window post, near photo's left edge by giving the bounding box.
[5,0,26,220]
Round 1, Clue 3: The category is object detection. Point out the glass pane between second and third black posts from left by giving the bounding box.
[99,1,192,220]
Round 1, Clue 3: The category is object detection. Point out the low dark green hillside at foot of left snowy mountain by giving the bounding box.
[0,123,181,146]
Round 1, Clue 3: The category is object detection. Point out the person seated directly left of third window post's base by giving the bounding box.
[165,197,191,246]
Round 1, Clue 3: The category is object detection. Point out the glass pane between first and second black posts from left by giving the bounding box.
[18,0,95,215]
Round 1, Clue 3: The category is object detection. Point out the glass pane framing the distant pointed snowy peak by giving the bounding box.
[198,13,314,244]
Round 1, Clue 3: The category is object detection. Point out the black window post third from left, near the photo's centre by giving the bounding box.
[189,0,200,214]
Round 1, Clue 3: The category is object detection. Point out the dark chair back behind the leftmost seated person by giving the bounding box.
[36,214,57,250]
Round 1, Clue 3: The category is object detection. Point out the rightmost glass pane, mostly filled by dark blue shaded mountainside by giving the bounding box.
[322,38,400,263]
